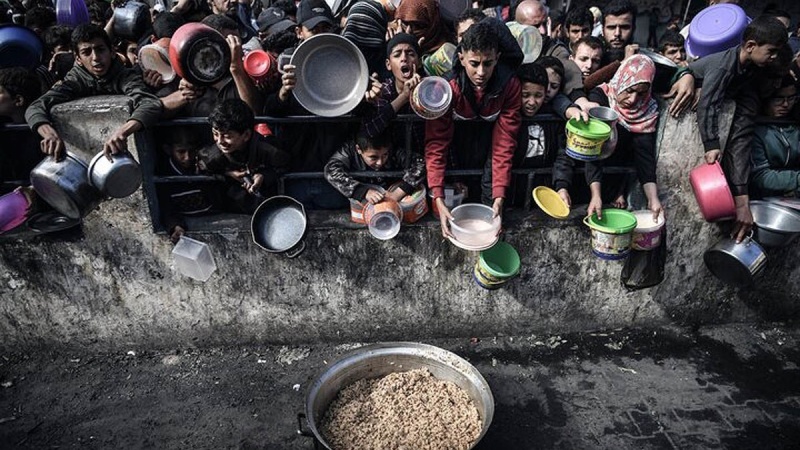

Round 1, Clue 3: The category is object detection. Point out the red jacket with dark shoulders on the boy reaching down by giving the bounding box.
[425,73,522,198]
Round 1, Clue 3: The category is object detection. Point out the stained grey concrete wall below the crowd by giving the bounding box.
[0,99,800,349]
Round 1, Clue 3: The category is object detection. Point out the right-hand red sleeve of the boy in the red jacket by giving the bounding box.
[492,77,522,199]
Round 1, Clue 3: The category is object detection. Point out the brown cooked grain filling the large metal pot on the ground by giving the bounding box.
[321,369,482,450]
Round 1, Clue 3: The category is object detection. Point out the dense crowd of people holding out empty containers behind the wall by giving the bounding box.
[0,0,800,244]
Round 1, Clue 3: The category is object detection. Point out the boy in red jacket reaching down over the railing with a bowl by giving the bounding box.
[425,19,522,237]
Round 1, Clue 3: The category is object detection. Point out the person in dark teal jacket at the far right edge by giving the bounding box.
[750,76,800,197]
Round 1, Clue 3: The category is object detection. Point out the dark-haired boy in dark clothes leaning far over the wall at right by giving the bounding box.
[689,16,788,242]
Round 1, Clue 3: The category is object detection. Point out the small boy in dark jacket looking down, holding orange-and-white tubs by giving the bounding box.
[325,132,425,204]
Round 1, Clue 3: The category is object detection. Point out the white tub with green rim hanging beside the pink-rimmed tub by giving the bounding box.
[583,209,636,261]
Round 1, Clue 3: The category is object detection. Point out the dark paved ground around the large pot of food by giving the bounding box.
[0,324,800,450]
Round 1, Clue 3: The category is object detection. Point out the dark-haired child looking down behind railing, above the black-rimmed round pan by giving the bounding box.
[200,99,289,214]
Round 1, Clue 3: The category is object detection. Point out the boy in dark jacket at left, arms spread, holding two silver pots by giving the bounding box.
[25,24,161,158]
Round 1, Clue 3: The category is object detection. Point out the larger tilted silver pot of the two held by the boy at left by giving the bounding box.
[31,152,103,219]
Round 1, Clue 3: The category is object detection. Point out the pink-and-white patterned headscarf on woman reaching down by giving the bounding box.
[600,55,658,133]
